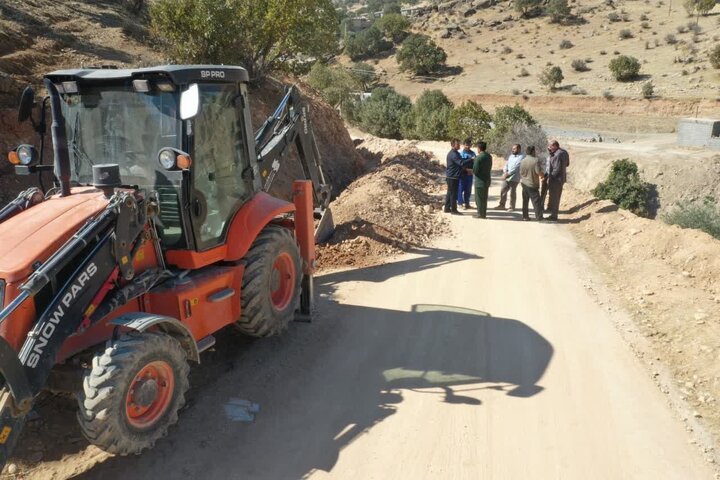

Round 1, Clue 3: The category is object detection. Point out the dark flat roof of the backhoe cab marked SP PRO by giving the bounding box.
[45,65,249,85]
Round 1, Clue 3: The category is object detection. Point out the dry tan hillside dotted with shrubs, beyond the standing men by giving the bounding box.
[366,0,720,127]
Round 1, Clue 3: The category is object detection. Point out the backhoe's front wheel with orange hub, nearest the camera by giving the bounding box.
[78,332,190,455]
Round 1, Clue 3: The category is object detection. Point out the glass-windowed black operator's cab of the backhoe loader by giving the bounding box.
[41,66,261,255]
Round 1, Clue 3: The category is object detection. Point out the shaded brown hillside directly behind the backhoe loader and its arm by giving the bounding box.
[0,0,362,204]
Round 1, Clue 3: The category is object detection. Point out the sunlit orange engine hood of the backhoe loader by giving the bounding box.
[0,187,108,283]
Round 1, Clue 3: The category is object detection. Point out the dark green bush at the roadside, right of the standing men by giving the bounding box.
[592,158,652,217]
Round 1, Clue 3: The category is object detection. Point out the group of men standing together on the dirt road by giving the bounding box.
[444,138,570,221]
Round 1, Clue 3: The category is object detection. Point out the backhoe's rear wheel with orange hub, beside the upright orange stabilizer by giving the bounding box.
[235,224,302,337]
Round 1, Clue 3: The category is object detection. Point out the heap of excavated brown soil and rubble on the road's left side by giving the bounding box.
[318,139,448,269]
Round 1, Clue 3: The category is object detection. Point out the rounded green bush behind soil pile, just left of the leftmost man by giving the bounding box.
[400,90,454,140]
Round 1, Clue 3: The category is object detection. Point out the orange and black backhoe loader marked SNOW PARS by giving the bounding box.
[0,65,332,468]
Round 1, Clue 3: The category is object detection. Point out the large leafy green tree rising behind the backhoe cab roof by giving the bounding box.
[150,0,338,81]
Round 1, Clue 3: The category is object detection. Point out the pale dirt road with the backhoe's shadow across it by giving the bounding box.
[44,180,713,480]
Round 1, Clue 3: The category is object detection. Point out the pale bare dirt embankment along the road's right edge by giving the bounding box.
[563,188,720,445]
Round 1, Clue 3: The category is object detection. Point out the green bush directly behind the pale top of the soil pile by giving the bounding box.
[356,87,412,139]
